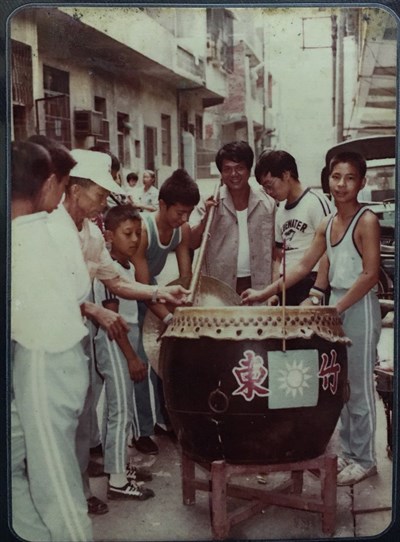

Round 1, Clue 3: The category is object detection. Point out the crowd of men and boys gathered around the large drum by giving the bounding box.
[10,136,381,541]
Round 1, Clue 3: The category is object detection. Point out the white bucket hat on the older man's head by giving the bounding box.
[70,149,125,194]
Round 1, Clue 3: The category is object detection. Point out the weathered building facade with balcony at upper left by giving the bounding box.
[10,7,233,184]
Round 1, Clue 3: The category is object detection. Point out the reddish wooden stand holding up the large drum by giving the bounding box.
[182,453,337,540]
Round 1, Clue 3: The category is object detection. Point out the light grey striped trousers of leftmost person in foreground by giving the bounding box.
[12,344,92,542]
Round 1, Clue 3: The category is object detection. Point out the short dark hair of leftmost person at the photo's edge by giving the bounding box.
[11,141,53,200]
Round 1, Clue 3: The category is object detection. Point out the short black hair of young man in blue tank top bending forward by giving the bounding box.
[158,169,200,207]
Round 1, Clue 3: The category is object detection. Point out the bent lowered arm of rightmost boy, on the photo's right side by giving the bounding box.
[336,212,380,314]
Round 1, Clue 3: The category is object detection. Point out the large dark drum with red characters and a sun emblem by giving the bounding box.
[161,307,349,464]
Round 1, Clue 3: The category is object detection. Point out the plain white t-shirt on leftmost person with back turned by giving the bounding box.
[11,212,87,353]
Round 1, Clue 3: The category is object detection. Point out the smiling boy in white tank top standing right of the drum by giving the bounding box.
[242,152,381,485]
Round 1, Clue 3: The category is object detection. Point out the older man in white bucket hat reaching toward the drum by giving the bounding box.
[48,149,189,514]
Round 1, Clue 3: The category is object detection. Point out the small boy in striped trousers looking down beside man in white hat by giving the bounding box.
[94,204,154,500]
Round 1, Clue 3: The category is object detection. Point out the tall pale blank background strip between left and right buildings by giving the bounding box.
[264,8,335,185]
